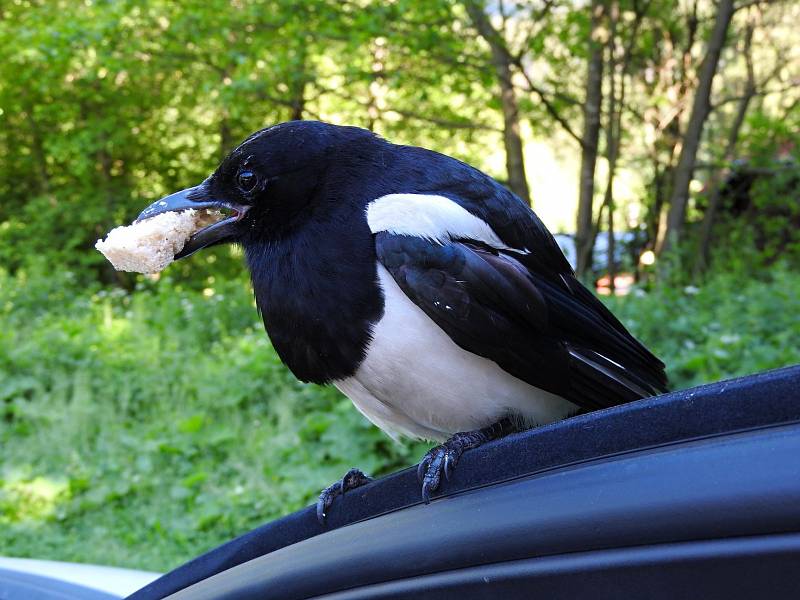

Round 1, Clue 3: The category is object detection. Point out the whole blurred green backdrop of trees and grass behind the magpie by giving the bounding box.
[0,0,800,570]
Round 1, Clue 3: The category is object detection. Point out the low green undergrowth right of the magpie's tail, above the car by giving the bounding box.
[608,265,800,389]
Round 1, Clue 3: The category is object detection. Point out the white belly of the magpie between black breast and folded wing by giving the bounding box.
[333,265,578,440]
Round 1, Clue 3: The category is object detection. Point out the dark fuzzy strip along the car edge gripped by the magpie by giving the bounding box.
[130,365,800,600]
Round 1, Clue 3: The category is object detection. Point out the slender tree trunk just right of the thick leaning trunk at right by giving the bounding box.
[695,22,757,276]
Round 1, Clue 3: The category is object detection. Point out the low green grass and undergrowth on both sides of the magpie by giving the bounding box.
[0,268,800,571]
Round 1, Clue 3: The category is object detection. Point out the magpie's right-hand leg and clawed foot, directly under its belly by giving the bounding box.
[417,419,518,504]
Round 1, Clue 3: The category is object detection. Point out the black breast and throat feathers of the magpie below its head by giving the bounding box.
[244,219,383,384]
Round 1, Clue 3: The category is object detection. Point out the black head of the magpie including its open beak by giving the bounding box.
[137,121,378,259]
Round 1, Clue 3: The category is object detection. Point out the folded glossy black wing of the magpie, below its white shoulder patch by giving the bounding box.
[375,230,666,410]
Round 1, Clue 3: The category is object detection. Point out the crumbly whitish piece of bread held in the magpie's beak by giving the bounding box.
[94,209,223,273]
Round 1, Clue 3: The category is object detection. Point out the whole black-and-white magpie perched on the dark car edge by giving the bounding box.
[139,121,667,520]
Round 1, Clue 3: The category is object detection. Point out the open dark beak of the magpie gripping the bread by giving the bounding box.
[136,181,250,260]
